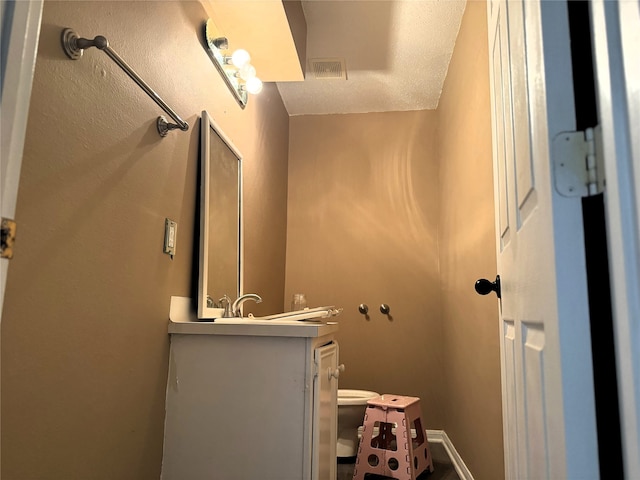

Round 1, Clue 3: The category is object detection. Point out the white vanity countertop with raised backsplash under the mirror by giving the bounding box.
[169,297,338,337]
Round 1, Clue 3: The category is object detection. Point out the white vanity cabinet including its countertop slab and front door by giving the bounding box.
[162,322,339,480]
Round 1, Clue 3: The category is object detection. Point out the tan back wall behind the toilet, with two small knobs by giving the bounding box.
[285,111,446,428]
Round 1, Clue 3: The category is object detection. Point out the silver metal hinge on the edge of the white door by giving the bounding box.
[553,125,605,197]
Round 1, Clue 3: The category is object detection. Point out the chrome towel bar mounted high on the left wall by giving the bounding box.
[62,28,189,137]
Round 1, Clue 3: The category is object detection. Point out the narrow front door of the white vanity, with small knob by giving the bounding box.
[311,342,339,480]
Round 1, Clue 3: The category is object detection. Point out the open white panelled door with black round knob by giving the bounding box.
[487,0,599,480]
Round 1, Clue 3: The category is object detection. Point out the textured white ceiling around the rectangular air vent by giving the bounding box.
[277,0,466,115]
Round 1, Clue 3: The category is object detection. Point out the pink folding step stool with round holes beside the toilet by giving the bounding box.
[353,394,433,480]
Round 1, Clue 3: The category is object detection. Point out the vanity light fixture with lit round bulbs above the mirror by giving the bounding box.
[204,19,262,108]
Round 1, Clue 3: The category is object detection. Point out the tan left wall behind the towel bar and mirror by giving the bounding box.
[1,1,288,480]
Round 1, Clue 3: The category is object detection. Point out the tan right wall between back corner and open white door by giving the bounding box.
[438,1,504,480]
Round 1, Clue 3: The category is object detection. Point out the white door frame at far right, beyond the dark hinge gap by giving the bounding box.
[591,0,640,479]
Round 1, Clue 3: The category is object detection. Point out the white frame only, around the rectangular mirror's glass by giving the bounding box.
[197,111,244,320]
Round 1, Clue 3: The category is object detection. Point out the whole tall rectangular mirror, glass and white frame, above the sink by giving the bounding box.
[198,111,242,320]
